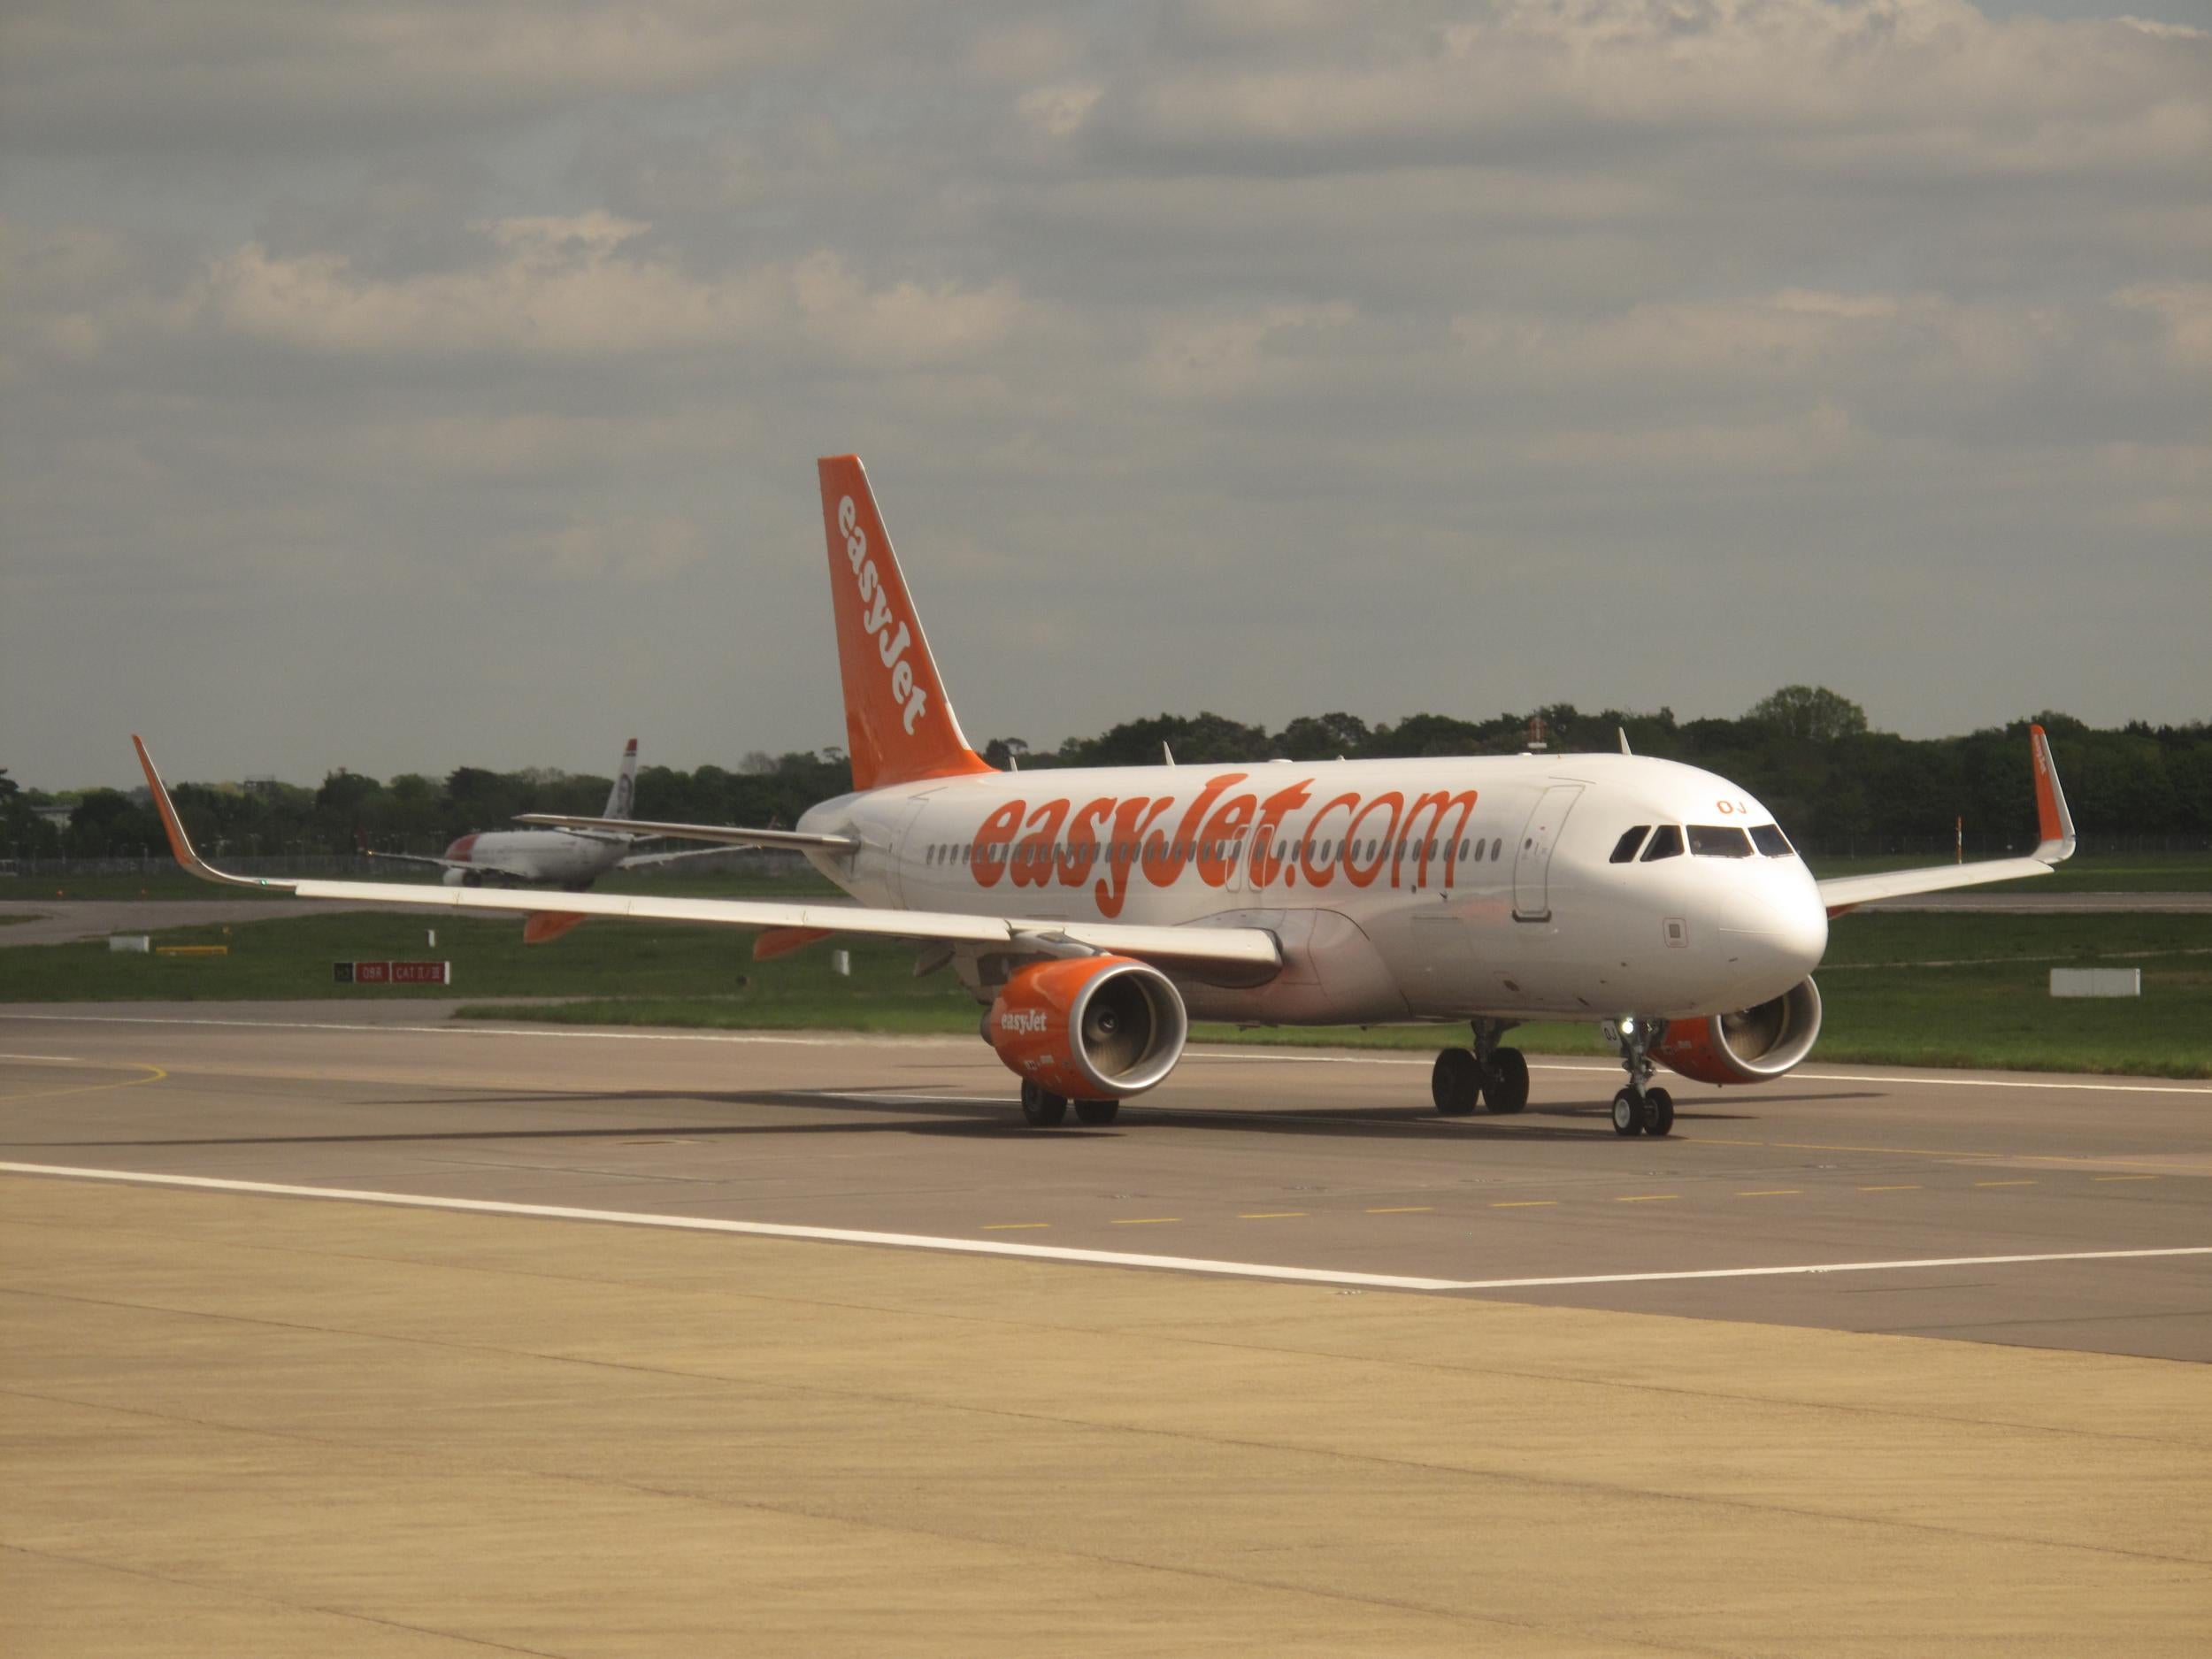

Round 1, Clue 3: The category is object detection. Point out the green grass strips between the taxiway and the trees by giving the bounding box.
[0,914,2212,1078]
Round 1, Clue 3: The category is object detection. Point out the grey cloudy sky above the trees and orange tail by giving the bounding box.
[0,0,2212,787]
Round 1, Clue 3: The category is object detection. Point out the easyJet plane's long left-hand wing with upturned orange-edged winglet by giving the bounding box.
[131,737,1283,967]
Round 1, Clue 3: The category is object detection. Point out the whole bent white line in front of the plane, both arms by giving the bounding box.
[0,1164,2212,1290]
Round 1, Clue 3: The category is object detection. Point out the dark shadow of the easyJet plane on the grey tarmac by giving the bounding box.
[16,1084,1878,1148]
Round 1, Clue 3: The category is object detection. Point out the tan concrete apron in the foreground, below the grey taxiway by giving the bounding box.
[0,1177,2212,1655]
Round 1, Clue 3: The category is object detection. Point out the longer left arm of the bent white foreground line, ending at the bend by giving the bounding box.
[0,1164,1460,1290]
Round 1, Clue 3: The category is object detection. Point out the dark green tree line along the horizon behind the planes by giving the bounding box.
[17,686,2212,858]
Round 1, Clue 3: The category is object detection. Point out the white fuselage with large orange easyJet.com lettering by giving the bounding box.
[801,755,1827,1025]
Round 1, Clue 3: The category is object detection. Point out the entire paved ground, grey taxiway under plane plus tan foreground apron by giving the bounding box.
[0,1004,2212,1655]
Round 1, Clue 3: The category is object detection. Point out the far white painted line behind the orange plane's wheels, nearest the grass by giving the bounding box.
[0,1013,2212,1095]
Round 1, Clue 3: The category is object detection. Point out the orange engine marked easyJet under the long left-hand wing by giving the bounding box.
[982,956,1190,1100]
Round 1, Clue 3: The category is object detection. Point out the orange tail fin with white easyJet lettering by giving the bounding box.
[821,456,994,790]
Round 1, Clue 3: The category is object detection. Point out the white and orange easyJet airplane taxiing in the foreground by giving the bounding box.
[133,456,2075,1135]
